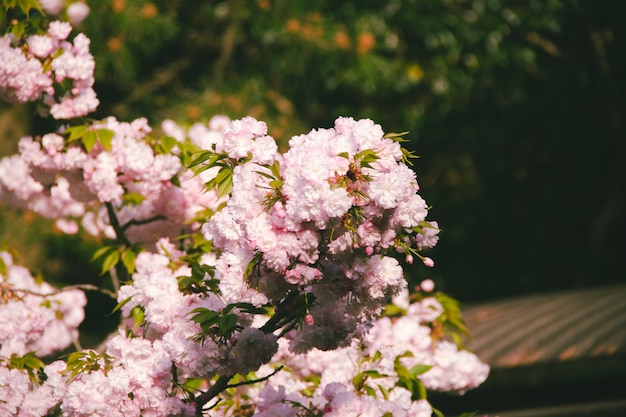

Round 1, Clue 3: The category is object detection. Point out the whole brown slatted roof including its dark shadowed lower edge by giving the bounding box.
[429,284,626,417]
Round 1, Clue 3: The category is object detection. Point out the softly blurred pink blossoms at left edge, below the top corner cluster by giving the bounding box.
[0,114,224,245]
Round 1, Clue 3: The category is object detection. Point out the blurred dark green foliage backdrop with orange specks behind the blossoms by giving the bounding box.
[1,0,626,302]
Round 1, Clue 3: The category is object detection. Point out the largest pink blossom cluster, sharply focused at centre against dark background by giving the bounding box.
[202,117,438,352]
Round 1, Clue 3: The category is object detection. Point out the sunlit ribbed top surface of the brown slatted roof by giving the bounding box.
[463,285,626,367]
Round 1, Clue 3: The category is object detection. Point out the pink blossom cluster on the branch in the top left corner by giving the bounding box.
[0,21,99,119]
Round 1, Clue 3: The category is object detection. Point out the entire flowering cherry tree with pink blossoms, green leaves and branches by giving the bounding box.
[0,1,489,417]
